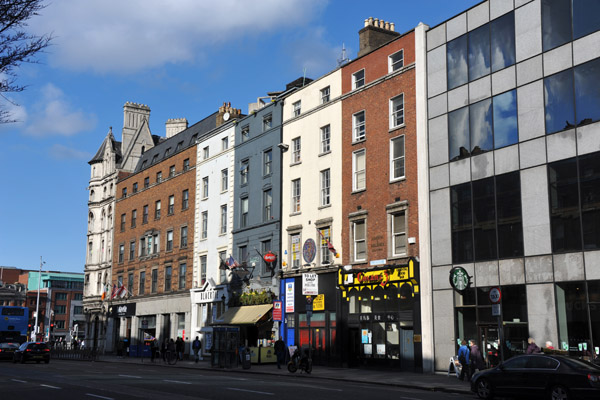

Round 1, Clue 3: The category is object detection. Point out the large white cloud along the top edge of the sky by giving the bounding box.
[31,0,326,73]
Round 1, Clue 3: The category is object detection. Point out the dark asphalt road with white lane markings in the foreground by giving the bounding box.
[0,360,475,400]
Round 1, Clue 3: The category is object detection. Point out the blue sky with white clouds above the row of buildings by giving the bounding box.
[0,0,480,272]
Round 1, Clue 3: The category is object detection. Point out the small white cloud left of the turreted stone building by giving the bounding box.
[23,83,97,136]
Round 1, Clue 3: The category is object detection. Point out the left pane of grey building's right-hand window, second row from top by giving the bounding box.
[544,69,575,134]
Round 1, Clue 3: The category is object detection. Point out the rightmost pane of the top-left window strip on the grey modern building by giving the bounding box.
[490,12,516,72]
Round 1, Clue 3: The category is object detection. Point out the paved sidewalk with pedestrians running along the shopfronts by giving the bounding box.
[98,355,472,394]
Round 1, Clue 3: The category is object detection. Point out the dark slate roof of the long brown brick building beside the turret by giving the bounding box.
[134,112,218,173]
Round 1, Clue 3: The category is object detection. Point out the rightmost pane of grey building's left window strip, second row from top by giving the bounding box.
[492,90,519,149]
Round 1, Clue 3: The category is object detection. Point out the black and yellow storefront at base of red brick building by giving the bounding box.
[338,258,422,371]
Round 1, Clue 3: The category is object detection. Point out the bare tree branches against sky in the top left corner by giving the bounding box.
[0,0,52,124]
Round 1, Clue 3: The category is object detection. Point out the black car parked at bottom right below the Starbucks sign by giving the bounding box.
[471,354,600,400]
